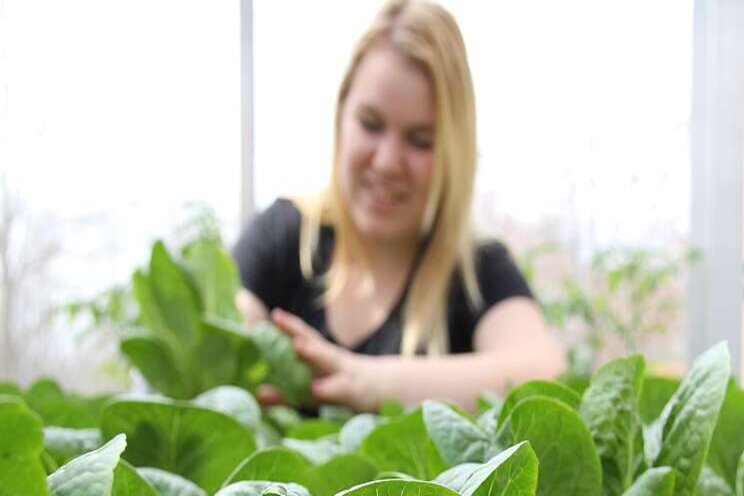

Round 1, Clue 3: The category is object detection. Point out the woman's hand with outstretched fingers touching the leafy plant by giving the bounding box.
[268,309,379,411]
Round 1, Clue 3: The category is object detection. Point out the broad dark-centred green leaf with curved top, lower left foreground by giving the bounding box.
[101,399,256,492]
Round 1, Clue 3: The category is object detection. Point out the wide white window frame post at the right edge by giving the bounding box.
[688,0,744,376]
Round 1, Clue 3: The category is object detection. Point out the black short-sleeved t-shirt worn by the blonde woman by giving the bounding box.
[233,199,532,355]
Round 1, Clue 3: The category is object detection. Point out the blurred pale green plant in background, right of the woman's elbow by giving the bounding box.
[519,242,700,382]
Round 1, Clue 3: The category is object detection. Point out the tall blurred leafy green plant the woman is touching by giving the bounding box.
[126,241,267,399]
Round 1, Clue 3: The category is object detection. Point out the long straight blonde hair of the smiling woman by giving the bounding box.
[298,0,481,355]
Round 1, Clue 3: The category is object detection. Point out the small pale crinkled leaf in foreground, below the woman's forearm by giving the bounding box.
[423,401,491,466]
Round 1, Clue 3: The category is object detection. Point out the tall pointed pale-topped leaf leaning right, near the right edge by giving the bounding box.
[647,343,731,496]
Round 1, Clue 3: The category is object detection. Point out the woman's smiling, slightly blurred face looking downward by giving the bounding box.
[339,46,435,241]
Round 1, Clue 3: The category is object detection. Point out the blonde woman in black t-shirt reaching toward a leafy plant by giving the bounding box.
[234,0,563,410]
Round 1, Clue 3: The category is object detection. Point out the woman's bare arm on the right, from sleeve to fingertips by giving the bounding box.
[272,297,564,410]
